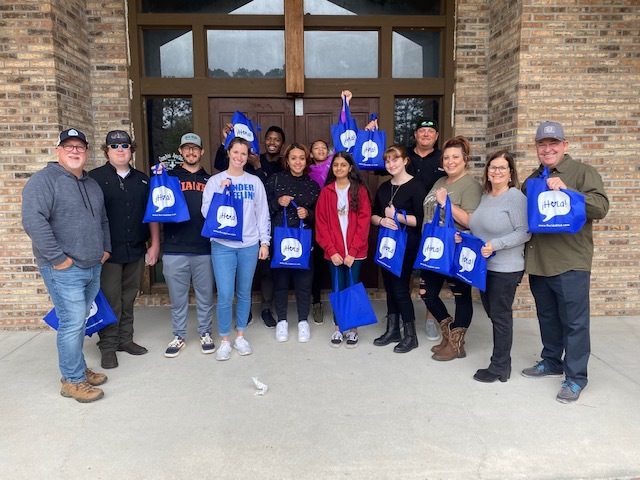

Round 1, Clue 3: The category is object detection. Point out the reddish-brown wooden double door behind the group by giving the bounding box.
[209,98,382,289]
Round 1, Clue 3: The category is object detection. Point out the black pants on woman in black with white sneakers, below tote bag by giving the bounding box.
[271,268,313,322]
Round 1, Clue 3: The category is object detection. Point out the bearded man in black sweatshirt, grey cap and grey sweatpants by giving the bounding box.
[162,133,215,358]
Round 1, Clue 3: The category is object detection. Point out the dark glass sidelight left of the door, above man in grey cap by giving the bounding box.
[146,97,193,167]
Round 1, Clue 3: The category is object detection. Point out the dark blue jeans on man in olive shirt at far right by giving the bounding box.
[529,270,591,388]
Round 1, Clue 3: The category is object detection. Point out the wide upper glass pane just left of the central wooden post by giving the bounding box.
[207,30,284,78]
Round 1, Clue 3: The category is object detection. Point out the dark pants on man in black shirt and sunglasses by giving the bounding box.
[98,258,144,352]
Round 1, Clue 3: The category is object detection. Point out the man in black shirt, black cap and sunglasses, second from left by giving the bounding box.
[89,130,160,368]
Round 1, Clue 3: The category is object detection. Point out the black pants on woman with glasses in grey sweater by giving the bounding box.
[480,271,524,375]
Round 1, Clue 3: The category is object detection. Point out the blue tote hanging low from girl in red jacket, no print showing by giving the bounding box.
[329,269,378,332]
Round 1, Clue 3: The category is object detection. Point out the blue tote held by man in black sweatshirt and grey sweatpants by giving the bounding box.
[142,163,191,223]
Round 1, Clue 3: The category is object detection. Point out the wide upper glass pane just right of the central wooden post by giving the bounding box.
[304,30,378,78]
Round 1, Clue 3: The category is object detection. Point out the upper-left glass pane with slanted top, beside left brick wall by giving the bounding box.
[143,30,193,78]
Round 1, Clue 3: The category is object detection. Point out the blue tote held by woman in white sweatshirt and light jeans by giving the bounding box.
[200,184,243,242]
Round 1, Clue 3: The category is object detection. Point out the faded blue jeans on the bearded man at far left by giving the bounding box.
[40,265,102,383]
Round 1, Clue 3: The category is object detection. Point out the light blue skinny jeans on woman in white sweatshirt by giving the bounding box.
[211,240,260,337]
